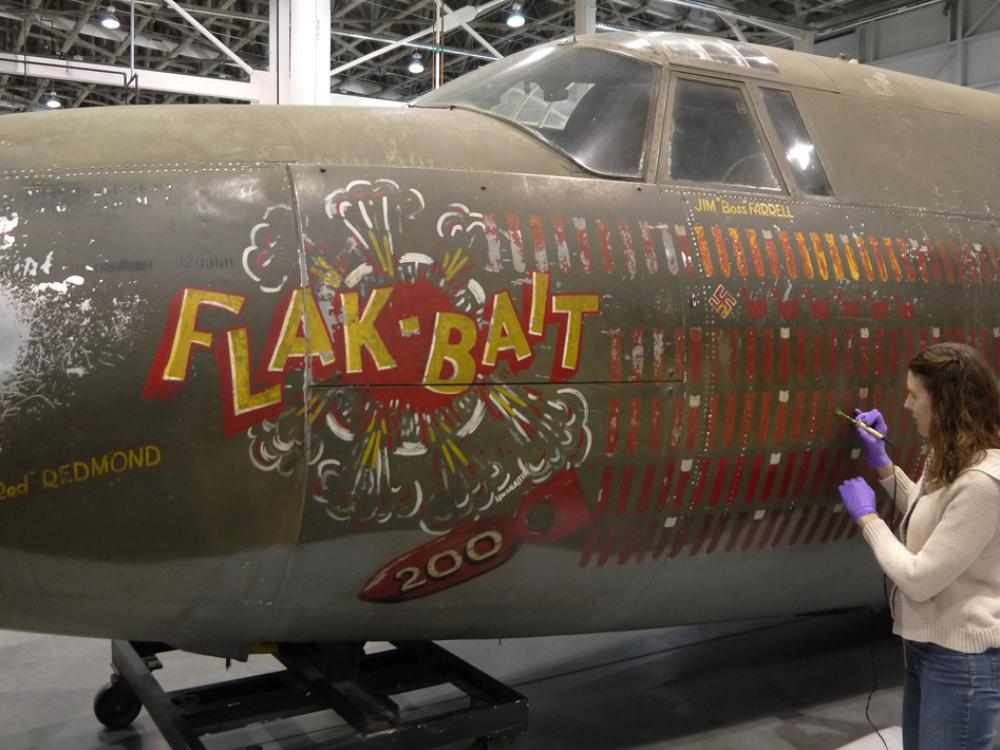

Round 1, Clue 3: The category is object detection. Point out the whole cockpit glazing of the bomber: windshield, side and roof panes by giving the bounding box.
[415,32,833,195]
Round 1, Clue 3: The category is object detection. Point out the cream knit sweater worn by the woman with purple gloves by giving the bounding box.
[864,449,1000,653]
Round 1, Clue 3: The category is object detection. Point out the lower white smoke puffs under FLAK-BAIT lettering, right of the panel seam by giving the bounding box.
[313,386,592,531]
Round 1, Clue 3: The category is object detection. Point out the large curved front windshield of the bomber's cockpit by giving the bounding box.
[415,45,659,177]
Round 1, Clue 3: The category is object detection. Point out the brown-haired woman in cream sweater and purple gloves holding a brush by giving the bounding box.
[840,343,1000,750]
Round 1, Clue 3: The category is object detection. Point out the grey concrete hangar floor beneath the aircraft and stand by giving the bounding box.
[0,613,902,750]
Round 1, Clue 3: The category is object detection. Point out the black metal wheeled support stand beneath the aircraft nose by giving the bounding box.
[94,641,528,750]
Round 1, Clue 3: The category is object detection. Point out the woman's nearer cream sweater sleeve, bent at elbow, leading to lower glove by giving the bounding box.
[863,471,1000,602]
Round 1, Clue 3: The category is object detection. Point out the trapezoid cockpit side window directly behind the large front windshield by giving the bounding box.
[670,79,781,190]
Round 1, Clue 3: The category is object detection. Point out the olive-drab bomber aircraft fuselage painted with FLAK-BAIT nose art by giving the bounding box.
[0,25,1000,748]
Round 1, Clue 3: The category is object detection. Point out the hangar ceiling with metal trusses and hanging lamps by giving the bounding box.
[0,0,958,113]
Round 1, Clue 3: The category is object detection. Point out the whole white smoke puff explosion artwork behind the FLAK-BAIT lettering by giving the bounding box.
[244,180,592,533]
